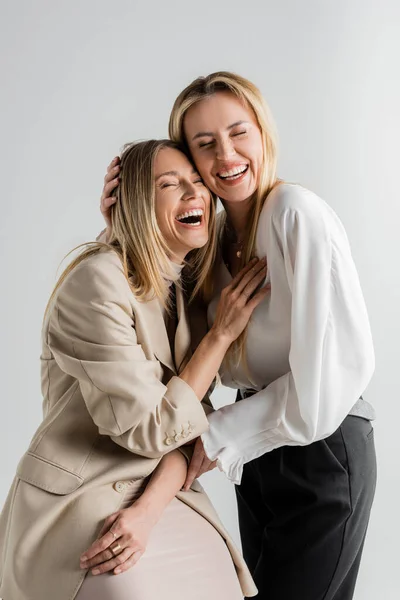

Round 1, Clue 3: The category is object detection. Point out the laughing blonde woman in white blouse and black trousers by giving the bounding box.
[102,72,376,600]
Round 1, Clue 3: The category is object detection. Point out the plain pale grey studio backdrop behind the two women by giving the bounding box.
[0,0,400,600]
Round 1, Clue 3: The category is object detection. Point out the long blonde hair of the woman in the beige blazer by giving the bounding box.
[45,140,216,314]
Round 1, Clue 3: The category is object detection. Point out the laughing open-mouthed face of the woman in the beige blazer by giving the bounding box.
[154,148,211,263]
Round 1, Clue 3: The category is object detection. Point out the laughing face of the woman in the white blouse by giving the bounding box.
[184,91,263,203]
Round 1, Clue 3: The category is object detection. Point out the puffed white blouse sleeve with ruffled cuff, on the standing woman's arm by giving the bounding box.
[202,190,375,483]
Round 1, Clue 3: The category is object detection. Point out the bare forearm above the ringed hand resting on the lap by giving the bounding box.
[131,450,187,521]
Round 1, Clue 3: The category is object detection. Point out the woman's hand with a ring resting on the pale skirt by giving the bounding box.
[80,501,158,575]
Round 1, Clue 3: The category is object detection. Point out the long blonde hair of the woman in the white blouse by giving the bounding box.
[169,71,279,364]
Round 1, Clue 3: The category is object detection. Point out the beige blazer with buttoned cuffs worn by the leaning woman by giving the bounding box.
[0,251,256,600]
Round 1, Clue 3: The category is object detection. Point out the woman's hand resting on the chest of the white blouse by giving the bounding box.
[210,258,271,342]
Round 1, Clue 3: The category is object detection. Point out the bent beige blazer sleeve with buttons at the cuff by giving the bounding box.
[48,254,208,458]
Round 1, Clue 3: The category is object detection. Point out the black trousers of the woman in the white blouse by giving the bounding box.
[235,416,376,600]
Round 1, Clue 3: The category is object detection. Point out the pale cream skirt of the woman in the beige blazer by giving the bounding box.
[75,481,243,600]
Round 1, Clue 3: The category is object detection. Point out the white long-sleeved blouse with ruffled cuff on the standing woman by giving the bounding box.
[201,184,375,484]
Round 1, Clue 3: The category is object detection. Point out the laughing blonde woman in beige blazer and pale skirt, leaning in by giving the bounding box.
[0,141,267,600]
